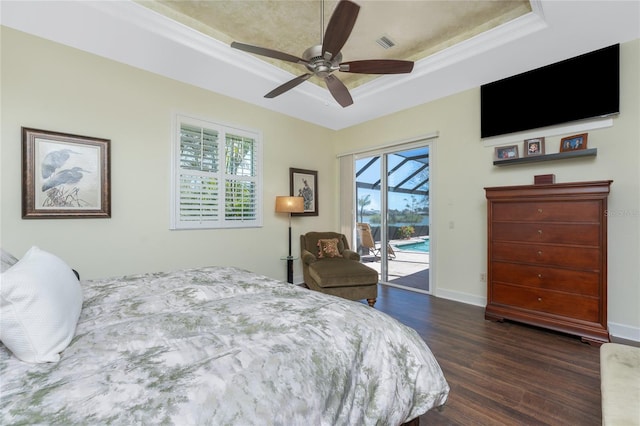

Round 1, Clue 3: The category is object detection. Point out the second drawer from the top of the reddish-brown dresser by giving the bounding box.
[491,222,600,246]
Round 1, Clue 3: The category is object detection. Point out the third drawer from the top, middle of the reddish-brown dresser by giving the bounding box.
[491,242,601,271]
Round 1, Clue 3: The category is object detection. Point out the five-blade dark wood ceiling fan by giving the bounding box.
[231,0,413,107]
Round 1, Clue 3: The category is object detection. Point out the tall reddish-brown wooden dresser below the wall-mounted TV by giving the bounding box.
[485,180,612,344]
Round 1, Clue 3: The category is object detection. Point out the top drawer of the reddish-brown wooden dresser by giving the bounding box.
[491,200,602,222]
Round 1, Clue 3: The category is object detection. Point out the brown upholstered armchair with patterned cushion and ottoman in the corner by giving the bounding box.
[300,232,378,306]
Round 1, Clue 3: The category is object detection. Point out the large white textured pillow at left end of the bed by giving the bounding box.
[0,247,82,363]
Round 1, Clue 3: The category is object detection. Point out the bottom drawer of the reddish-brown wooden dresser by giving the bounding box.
[491,283,600,322]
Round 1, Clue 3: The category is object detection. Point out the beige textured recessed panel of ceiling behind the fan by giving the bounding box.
[138,0,531,88]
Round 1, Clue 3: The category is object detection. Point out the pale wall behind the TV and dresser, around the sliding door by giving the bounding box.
[336,40,640,340]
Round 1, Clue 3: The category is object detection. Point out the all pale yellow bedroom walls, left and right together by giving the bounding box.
[0,27,640,340]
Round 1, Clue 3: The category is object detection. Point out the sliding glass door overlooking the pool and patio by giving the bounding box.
[355,144,431,293]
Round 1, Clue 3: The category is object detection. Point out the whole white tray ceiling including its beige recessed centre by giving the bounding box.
[0,0,640,132]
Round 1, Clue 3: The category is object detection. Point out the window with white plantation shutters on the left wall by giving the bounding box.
[171,115,262,229]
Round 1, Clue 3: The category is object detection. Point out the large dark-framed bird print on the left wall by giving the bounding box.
[22,127,111,219]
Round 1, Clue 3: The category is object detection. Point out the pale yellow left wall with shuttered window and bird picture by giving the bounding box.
[0,27,335,280]
